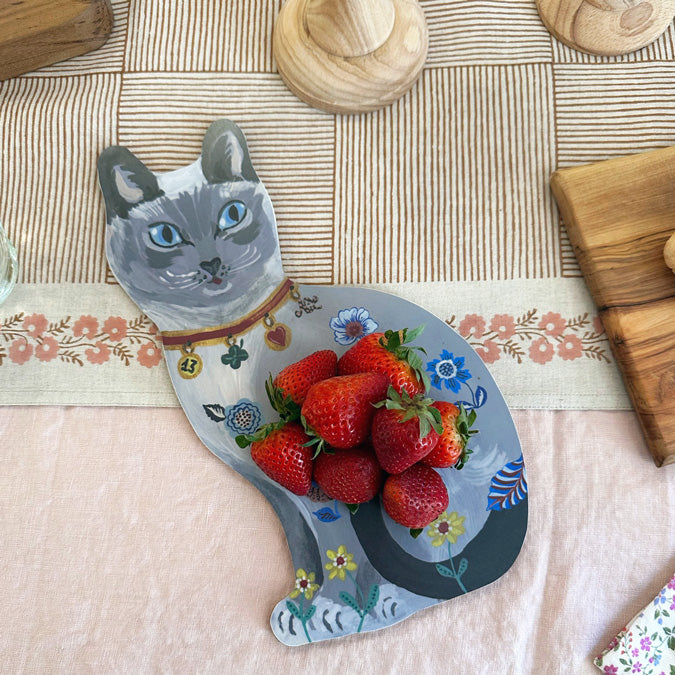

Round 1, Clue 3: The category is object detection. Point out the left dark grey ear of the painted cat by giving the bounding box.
[98,145,164,221]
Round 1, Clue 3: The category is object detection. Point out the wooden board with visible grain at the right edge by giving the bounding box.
[551,147,675,466]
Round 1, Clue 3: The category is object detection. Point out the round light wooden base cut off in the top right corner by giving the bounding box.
[537,0,675,56]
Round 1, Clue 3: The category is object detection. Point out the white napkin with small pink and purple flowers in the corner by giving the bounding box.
[594,574,675,675]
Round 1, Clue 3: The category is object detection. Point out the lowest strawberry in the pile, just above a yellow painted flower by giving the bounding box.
[382,464,448,536]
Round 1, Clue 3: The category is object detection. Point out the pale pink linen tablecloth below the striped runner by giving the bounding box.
[0,406,675,675]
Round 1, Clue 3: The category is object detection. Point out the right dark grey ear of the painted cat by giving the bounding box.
[202,119,258,183]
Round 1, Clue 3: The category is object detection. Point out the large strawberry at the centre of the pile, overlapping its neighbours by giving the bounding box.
[302,373,389,450]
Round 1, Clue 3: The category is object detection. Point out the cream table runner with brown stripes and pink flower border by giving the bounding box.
[0,0,675,408]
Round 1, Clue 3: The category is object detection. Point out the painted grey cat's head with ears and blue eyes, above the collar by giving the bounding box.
[99,120,281,327]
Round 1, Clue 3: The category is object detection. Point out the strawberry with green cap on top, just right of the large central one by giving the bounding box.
[371,386,443,473]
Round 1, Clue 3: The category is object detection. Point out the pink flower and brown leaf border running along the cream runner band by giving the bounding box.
[0,309,611,368]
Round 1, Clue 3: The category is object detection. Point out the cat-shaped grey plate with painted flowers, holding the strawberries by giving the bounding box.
[99,120,527,645]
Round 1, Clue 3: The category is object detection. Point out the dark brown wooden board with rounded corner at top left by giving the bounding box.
[0,0,113,80]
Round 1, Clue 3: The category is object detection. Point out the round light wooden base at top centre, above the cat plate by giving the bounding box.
[273,0,429,113]
